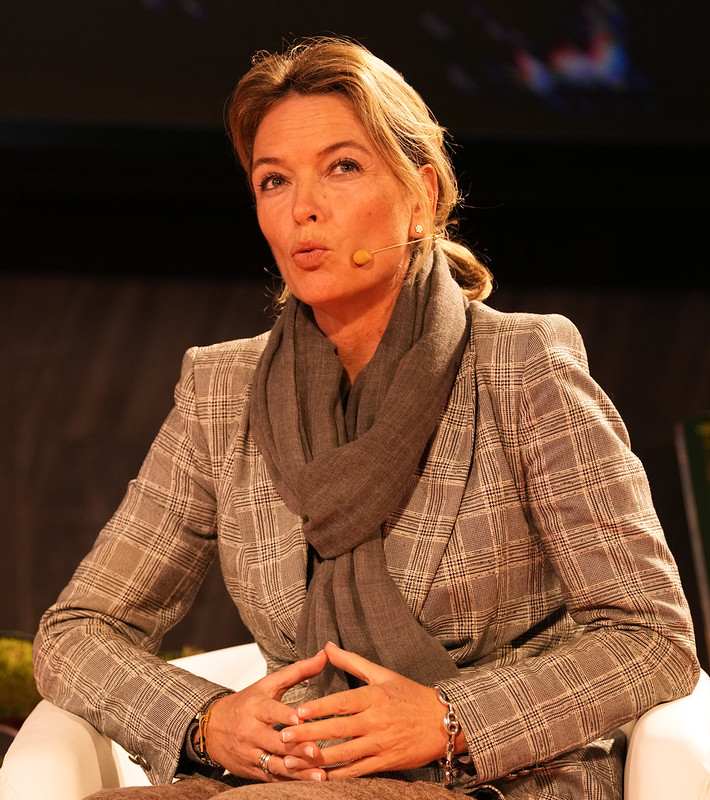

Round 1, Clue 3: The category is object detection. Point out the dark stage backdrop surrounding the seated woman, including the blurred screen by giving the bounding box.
[0,0,710,665]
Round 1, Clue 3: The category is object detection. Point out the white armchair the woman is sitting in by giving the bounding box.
[0,644,710,800]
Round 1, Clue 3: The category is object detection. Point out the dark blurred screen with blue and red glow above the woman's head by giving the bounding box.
[0,0,710,143]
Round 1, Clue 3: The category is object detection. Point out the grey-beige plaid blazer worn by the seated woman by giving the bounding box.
[35,303,699,798]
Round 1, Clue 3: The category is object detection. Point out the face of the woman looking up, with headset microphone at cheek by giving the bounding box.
[251,94,435,319]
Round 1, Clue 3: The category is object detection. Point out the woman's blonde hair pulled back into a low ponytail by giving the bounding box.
[227,38,493,300]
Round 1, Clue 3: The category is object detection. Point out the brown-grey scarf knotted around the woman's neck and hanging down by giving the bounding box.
[250,248,467,695]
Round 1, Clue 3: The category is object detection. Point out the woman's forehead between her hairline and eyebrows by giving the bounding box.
[253,94,374,164]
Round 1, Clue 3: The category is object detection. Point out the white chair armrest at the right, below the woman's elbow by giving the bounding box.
[624,672,710,800]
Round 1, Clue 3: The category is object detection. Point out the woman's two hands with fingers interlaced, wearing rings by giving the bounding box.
[207,643,456,781]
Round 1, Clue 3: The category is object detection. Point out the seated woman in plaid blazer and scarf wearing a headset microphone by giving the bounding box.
[36,40,698,800]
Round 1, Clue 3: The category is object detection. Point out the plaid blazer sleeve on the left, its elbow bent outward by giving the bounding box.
[35,349,238,783]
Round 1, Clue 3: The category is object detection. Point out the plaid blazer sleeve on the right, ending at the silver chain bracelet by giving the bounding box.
[442,316,699,781]
